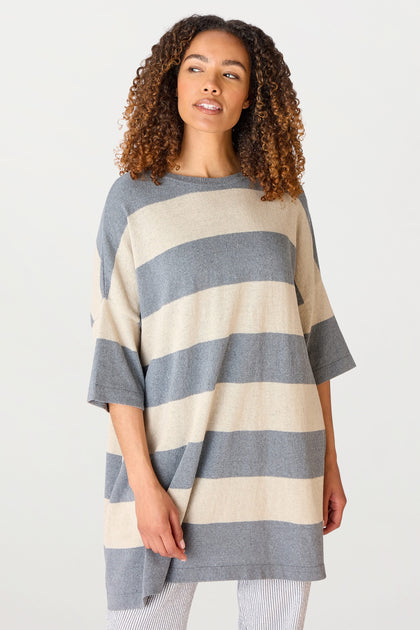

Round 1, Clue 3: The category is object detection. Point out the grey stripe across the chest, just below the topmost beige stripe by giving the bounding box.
[136,231,296,318]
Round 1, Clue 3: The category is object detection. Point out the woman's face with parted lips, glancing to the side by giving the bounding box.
[177,31,250,132]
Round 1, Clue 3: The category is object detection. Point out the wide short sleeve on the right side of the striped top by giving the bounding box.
[295,192,356,385]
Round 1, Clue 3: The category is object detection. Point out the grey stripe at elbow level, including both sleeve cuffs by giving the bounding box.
[88,324,355,409]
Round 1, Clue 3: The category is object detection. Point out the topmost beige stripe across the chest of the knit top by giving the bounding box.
[128,189,301,267]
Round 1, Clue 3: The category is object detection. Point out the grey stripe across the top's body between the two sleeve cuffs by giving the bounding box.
[145,333,316,407]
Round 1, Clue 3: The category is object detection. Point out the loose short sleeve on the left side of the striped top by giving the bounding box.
[88,180,144,411]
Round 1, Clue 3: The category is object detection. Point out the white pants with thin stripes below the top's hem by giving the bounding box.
[107,579,311,630]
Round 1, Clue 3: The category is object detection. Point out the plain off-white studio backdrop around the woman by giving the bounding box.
[0,0,420,630]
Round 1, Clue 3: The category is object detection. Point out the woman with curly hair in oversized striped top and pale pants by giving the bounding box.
[88,15,355,630]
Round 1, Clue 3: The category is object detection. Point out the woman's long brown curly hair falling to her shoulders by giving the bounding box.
[115,15,305,201]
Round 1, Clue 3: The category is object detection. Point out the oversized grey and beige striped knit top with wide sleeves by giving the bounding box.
[88,173,356,610]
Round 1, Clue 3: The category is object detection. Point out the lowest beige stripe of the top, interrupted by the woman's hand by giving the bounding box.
[104,477,324,549]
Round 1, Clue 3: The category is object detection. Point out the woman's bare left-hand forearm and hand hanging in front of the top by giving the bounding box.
[109,403,187,561]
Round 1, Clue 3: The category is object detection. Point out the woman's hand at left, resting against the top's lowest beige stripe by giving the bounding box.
[134,483,187,561]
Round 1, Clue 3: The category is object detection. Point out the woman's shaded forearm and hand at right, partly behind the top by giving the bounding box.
[317,380,347,534]
